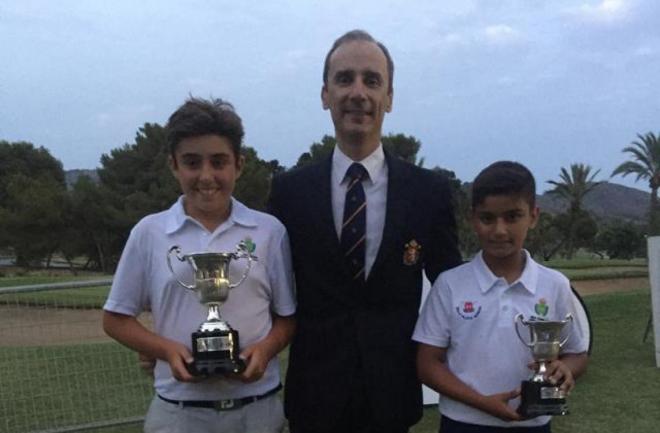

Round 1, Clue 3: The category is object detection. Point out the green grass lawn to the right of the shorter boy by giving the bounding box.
[554,291,660,433]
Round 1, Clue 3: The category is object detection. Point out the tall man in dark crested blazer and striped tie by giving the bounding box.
[270,30,460,433]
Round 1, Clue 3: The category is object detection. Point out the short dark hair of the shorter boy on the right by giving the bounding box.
[472,161,536,209]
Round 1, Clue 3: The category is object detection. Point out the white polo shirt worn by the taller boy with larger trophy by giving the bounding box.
[103,197,295,400]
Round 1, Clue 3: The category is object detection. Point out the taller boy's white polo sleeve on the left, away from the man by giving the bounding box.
[103,224,149,317]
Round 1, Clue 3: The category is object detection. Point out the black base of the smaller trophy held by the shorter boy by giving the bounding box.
[518,380,568,418]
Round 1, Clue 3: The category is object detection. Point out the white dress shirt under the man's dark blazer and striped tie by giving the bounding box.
[331,144,387,277]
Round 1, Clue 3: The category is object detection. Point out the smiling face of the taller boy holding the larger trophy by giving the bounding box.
[170,135,243,230]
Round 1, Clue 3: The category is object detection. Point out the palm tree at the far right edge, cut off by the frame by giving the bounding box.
[612,132,660,235]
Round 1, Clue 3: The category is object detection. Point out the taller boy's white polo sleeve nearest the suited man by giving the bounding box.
[266,224,296,316]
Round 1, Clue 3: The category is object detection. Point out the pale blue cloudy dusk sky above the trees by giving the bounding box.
[0,0,660,190]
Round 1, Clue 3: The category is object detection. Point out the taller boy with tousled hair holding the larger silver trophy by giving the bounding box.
[103,98,295,433]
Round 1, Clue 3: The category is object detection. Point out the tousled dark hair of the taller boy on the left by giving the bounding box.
[167,97,245,160]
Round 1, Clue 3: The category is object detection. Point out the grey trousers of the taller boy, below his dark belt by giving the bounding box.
[144,395,284,433]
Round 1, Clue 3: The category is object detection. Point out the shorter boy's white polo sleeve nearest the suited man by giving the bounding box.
[412,273,452,348]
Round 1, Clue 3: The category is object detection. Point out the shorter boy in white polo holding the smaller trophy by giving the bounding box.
[413,161,588,433]
